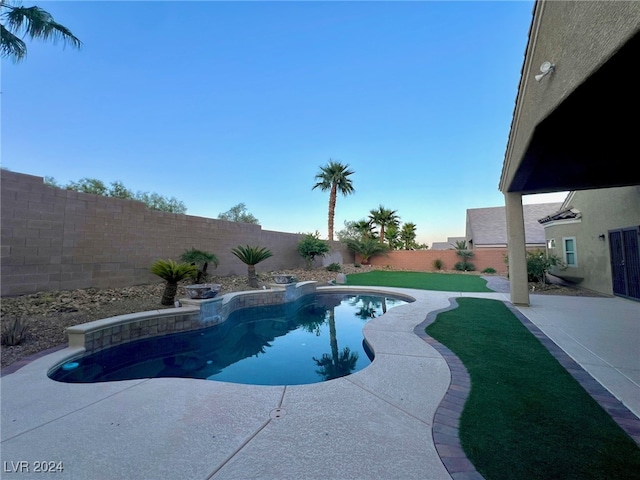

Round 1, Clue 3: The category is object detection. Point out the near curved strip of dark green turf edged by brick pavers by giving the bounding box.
[426,298,640,480]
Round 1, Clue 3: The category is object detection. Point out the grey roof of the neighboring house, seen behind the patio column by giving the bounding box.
[467,203,562,248]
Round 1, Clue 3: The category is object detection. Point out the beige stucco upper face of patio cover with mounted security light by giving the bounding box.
[500,0,640,193]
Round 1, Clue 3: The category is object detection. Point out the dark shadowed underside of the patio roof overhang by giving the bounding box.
[503,32,640,194]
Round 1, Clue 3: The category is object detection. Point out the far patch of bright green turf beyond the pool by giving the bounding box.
[347,270,493,292]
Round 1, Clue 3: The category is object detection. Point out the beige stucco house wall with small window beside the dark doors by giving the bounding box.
[545,186,640,295]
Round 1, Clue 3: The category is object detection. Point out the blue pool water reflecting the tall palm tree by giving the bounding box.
[50,293,407,385]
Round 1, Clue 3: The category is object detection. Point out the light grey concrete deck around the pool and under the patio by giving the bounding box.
[0,288,640,480]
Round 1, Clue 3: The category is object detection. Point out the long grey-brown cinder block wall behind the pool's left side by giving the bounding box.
[0,170,353,296]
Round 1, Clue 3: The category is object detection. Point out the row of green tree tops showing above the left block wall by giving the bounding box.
[44,177,187,213]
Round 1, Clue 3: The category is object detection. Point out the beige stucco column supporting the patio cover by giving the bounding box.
[504,192,529,306]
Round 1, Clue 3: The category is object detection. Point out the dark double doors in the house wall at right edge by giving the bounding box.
[609,227,640,300]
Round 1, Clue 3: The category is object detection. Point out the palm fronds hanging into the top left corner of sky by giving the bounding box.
[0,0,82,63]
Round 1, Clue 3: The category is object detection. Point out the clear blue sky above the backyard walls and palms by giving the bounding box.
[2,1,568,245]
